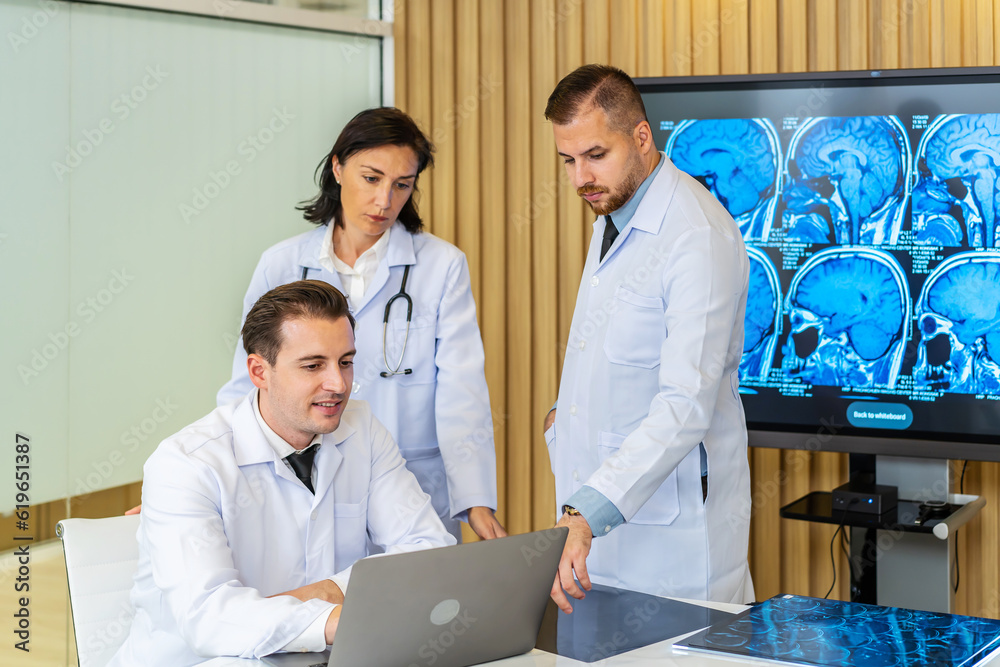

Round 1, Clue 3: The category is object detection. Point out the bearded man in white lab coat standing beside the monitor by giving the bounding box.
[545,65,753,612]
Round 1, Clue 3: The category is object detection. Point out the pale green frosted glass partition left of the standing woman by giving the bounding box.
[0,0,381,512]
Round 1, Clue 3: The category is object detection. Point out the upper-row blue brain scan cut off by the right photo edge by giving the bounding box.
[912,114,1000,248]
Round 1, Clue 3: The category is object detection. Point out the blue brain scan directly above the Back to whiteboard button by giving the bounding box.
[782,248,910,388]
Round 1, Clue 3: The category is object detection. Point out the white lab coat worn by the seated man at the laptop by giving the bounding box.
[111,393,455,667]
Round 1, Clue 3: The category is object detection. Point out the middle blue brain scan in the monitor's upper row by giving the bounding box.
[781,116,911,245]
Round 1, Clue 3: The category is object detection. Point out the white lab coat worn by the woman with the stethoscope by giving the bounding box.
[218,222,497,539]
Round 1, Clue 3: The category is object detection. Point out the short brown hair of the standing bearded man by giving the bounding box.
[545,65,646,137]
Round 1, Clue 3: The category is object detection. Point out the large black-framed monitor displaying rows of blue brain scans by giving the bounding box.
[636,68,1000,460]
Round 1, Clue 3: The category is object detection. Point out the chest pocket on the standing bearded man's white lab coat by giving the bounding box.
[604,285,667,368]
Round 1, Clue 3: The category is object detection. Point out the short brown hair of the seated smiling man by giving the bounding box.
[241,280,354,366]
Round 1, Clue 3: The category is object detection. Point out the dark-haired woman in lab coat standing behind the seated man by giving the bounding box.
[217,107,506,540]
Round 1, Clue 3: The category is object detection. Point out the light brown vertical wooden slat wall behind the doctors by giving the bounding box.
[395,0,1000,617]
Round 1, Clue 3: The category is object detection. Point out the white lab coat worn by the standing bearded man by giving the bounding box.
[546,154,753,602]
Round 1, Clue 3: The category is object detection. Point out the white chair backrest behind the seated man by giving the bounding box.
[56,515,139,667]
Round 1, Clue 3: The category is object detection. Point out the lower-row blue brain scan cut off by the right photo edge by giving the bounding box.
[913,252,1000,394]
